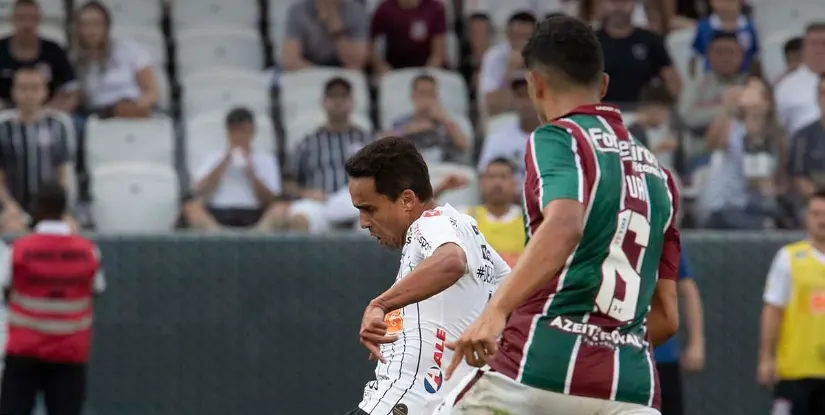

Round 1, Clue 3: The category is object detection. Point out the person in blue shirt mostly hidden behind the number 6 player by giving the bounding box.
[654,250,705,415]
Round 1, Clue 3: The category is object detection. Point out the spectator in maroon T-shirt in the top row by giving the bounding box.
[370,0,447,75]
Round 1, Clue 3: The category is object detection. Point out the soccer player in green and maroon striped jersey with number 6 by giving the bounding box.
[435,16,680,415]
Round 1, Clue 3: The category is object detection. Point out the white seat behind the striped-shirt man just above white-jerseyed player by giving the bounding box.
[280,68,369,119]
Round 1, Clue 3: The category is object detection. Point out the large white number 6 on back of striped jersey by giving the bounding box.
[596,210,650,322]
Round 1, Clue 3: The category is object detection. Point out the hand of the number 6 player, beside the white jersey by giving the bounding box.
[446,307,507,380]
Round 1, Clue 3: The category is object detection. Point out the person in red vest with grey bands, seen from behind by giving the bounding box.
[0,183,106,415]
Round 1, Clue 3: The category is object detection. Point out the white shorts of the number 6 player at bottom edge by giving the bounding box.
[433,369,661,415]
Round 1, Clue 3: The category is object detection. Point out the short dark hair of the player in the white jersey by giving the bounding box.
[346,136,433,201]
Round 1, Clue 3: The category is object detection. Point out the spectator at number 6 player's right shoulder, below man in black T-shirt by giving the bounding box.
[627,84,679,170]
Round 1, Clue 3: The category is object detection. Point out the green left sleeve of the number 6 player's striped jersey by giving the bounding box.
[536,122,592,208]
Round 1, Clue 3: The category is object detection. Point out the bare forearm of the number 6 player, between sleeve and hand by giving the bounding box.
[488,201,583,315]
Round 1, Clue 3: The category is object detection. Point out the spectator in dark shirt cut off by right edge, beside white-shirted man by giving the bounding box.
[788,74,825,203]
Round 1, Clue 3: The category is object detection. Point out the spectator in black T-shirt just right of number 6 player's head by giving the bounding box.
[597,0,682,105]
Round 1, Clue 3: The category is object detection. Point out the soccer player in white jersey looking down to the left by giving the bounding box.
[346,137,510,415]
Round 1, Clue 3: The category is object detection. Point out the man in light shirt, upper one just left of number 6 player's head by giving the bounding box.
[478,12,536,116]
